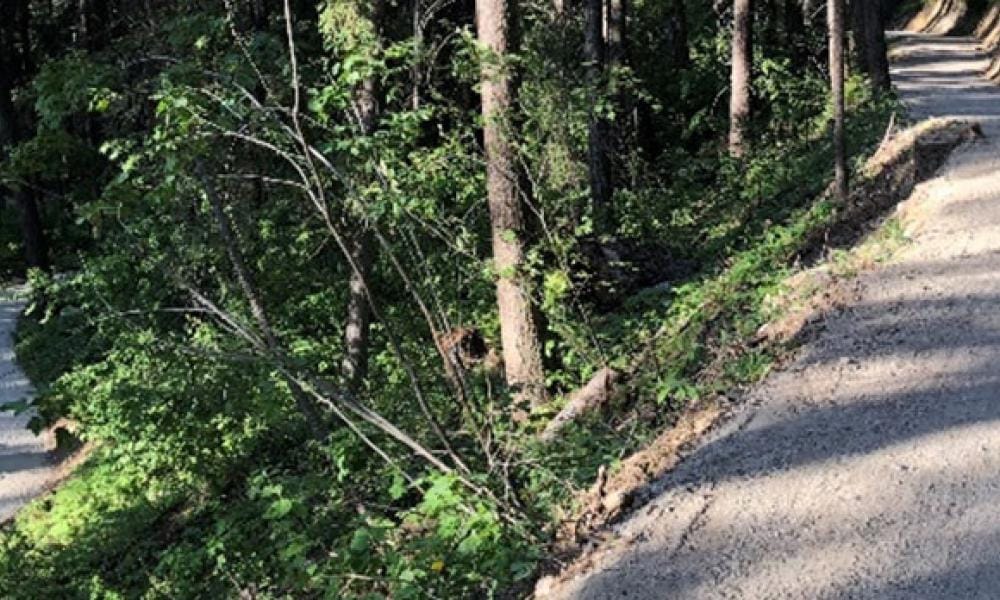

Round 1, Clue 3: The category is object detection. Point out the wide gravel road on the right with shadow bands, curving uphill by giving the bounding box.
[544,36,1000,599]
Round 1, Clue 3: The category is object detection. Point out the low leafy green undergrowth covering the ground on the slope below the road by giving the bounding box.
[0,85,898,598]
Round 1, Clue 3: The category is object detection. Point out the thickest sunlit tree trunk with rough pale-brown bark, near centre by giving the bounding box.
[476,0,545,407]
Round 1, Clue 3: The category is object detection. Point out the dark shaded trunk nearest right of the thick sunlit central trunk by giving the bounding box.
[583,0,620,231]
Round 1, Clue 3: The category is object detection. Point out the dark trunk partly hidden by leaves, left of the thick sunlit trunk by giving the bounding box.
[341,0,384,392]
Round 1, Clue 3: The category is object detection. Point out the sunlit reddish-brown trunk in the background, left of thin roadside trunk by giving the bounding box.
[729,0,753,157]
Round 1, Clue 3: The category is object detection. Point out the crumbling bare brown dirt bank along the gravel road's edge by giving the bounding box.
[539,119,978,597]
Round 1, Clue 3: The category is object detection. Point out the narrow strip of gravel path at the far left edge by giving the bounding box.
[0,301,57,522]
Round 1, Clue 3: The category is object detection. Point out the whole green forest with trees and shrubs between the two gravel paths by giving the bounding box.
[0,0,914,599]
